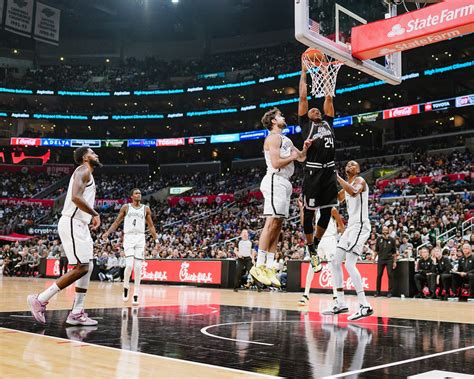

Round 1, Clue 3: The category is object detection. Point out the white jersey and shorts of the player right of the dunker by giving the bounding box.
[337,180,370,255]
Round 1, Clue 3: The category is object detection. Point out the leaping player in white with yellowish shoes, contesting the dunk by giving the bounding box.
[250,108,311,287]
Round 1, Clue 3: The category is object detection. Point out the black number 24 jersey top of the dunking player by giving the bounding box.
[299,114,336,168]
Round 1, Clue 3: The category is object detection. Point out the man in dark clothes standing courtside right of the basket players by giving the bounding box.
[374,226,397,297]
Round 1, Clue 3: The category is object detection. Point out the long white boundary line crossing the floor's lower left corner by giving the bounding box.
[0,326,283,379]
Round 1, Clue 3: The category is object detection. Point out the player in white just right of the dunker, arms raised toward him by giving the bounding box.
[332,161,374,320]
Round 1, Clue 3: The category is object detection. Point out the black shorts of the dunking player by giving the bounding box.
[303,167,339,209]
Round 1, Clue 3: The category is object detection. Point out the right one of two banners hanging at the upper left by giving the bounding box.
[34,3,61,45]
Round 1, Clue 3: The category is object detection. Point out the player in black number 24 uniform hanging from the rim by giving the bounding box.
[298,60,338,272]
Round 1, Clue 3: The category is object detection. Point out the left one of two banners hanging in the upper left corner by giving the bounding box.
[5,0,34,37]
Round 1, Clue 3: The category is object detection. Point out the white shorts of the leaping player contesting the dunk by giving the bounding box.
[260,174,293,217]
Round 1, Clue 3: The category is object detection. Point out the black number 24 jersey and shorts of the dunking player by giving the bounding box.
[299,115,338,209]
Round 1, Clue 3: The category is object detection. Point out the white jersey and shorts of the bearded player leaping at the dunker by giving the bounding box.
[260,135,295,217]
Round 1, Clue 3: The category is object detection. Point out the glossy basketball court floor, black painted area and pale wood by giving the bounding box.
[0,278,474,378]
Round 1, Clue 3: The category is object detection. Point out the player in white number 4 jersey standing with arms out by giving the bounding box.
[102,188,158,305]
